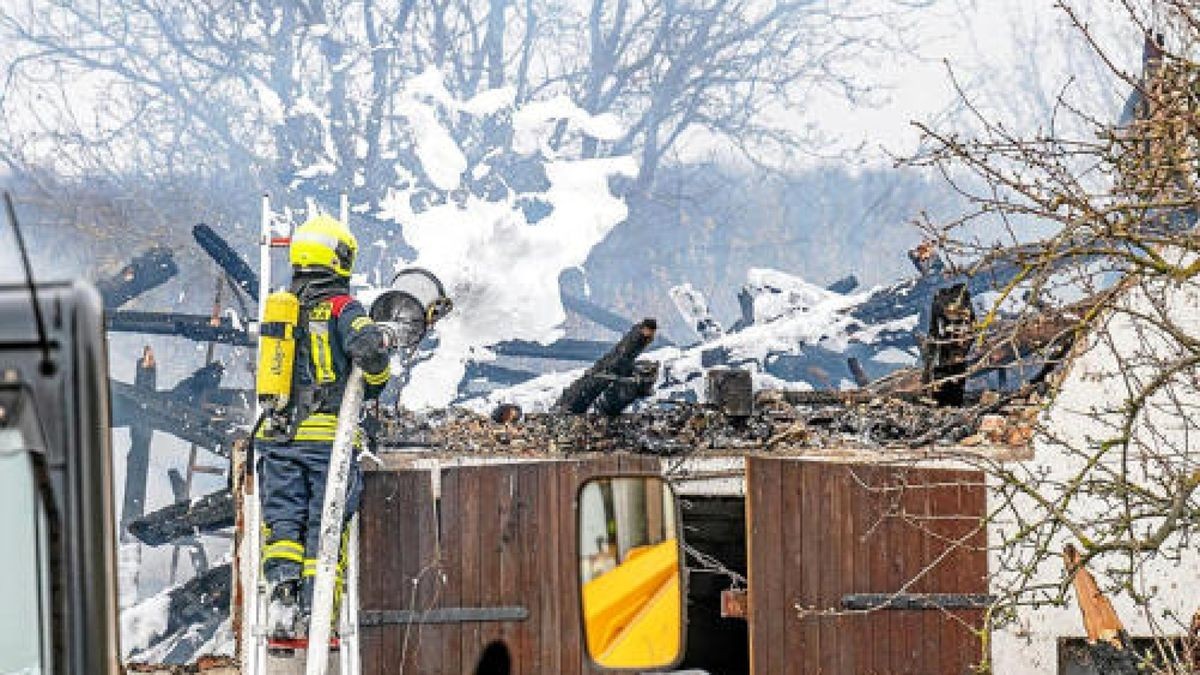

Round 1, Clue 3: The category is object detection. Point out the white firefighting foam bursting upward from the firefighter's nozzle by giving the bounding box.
[379,71,637,408]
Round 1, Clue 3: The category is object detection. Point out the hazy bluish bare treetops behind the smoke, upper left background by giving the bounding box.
[0,0,920,220]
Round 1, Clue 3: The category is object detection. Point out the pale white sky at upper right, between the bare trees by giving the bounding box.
[683,0,1141,168]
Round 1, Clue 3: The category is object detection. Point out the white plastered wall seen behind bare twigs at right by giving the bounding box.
[989,270,1200,675]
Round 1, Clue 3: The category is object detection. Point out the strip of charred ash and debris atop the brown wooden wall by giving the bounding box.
[379,387,1043,455]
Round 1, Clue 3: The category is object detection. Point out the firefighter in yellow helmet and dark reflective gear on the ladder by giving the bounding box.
[256,215,391,640]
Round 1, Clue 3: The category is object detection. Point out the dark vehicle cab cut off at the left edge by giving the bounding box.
[0,282,120,675]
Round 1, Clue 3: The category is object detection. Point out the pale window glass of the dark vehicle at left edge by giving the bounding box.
[0,441,43,675]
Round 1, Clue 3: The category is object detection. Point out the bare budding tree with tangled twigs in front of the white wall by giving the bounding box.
[913,1,1200,673]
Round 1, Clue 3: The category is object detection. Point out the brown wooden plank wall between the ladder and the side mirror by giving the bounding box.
[360,456,659,675]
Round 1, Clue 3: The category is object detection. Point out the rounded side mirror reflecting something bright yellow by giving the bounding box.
[575,476,685,670]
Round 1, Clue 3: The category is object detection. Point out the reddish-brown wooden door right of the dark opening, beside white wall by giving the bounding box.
[746,458,988,675]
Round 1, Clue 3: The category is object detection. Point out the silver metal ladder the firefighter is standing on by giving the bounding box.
[234,195,362,675]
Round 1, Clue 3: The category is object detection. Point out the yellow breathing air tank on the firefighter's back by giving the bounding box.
[254,291,300,422]
